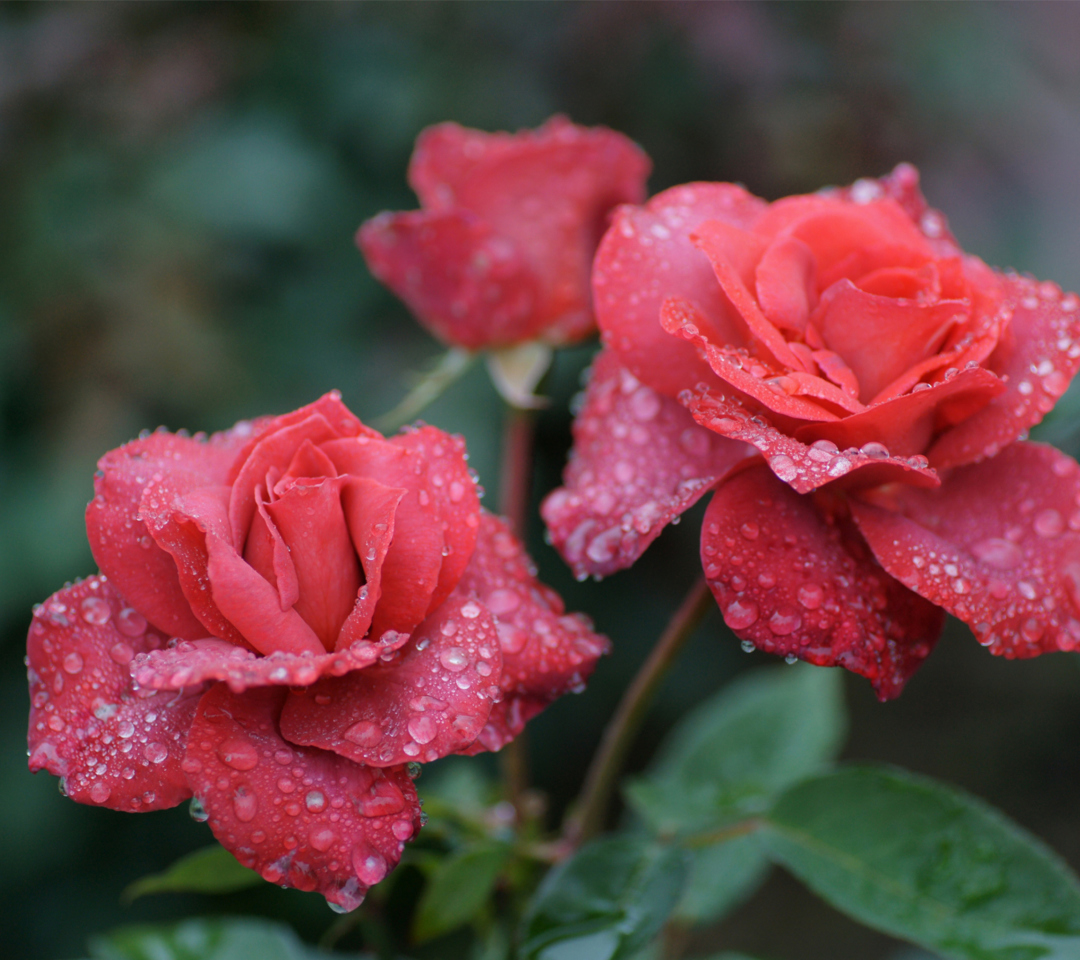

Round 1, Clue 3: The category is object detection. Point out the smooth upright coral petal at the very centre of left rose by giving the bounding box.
[267,477,363,650]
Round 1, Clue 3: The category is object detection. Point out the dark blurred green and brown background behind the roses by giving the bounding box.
[0,2,1080,960]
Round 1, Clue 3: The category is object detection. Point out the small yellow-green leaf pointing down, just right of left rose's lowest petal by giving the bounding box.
[413,842,511,941]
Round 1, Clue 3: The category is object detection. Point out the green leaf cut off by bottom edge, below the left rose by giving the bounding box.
[90,917,341,960]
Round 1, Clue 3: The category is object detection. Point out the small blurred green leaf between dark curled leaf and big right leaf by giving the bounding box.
[675,835,769,923]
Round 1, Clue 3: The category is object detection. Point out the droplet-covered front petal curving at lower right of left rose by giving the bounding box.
[281,592,502,767]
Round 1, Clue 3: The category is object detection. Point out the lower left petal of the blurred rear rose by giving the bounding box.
[356,209,543,350]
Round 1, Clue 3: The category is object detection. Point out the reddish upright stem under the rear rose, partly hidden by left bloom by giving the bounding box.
[499,407,536,822]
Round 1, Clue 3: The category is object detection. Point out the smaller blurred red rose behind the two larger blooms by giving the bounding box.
[356,117,650,350]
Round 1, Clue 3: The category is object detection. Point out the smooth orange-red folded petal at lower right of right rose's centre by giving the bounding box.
[794,367,1004,457]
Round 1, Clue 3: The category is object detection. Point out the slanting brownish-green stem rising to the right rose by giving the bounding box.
[563,577,712,849]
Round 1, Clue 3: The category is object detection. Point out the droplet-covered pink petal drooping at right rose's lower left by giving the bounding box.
[541,350,748,577]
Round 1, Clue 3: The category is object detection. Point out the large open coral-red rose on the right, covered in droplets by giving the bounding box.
[543,165,1080,699]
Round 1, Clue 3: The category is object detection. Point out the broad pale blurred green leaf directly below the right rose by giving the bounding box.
[626,665,846,833]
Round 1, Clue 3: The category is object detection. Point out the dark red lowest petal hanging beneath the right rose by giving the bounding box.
[701,464,944,700]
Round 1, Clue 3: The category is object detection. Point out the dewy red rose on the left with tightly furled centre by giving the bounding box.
[27,393,606,909]
